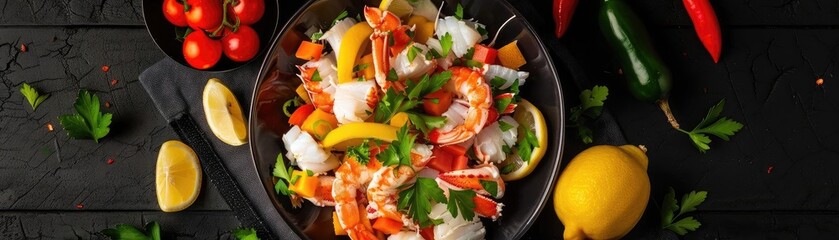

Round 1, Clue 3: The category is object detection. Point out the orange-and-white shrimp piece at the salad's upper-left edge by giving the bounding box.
[297,52,338,113]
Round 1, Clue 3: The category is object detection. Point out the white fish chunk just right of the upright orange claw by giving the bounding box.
[391,43,437,79]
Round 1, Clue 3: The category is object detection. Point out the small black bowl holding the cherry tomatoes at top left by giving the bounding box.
[143,0,279,72]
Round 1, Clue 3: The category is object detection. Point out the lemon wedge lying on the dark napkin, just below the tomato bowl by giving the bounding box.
[204,78,248,146]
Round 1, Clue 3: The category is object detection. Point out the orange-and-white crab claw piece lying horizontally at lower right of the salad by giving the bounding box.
[438,164,504,198]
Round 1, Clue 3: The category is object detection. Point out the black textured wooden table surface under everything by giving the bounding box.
[0,0,839,239]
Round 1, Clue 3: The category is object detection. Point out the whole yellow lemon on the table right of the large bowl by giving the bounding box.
[554,145,650,239]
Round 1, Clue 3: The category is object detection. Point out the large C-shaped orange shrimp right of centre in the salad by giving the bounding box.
[428,67,492,145]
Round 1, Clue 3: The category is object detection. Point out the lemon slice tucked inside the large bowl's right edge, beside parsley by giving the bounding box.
[500,99,548,181]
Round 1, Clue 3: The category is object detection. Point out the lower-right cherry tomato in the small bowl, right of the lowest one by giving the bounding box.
[221,25,259,62]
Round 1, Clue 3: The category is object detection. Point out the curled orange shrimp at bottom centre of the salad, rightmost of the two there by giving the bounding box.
[367,144,431,226]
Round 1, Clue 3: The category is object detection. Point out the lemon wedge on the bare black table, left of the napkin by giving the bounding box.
[155,140,201,212]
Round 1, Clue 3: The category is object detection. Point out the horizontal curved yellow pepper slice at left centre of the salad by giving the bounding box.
[321,122,399,147]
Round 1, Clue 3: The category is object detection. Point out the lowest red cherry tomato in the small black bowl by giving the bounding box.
[183,31,221,69]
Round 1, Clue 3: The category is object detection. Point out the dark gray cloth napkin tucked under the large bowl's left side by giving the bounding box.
[140,57,299,239]
